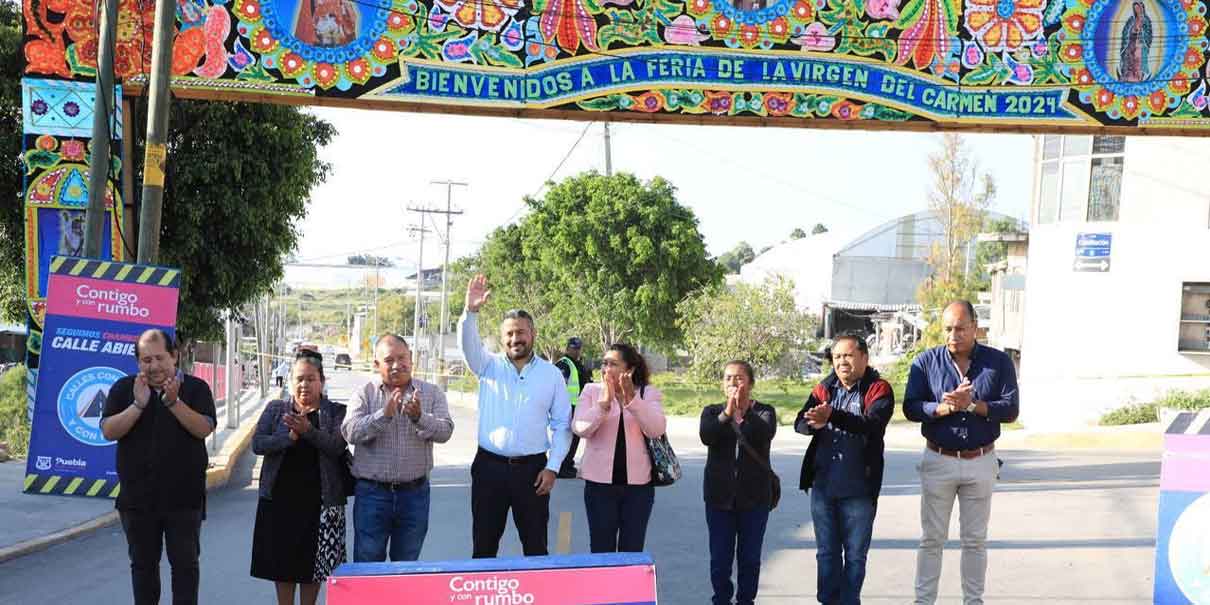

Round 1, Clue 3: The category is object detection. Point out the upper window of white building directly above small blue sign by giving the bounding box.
[1037,134,1125,224]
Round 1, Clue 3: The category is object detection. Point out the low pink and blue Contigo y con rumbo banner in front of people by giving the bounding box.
[328,553,656,605]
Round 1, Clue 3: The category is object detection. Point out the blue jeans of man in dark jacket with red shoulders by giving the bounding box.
[811,489,874,605]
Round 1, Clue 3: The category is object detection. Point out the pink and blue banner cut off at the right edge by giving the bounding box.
[1154,410,1210,605]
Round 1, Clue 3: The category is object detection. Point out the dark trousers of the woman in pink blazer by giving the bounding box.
[584,480,656,553]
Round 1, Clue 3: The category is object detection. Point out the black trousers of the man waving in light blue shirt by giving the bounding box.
[471,449,551,559]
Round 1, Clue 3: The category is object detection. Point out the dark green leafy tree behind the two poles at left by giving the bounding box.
[0,7,335,338]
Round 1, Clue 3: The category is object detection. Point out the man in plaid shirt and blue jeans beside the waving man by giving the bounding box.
[341,334,454,563]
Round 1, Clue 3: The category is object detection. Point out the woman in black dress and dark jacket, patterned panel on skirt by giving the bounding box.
[252,351,346,605]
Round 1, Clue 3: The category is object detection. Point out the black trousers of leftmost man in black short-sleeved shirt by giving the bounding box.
[120,509,202,605]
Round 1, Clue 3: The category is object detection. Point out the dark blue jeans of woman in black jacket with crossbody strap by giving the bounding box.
[705,505,768,605]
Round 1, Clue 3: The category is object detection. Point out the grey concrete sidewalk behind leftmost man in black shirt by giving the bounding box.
[0,391,278,563]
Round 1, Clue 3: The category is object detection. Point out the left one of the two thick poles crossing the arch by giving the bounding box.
[83,0,118,259]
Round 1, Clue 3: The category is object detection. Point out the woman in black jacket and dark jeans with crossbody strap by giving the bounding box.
[699,361,777,605]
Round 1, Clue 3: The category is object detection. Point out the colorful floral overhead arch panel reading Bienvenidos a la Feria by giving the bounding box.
[16,0,1210,134]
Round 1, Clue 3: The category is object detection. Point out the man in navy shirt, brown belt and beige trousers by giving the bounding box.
[904,300,1019,605]
